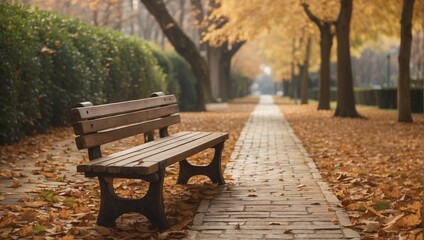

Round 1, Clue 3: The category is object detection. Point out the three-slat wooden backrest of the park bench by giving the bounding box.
[71,92,180,149]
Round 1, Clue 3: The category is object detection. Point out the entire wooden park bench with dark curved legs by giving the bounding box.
[71,92,228,230]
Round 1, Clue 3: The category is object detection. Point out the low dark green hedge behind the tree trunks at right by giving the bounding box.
[309,88,424,113]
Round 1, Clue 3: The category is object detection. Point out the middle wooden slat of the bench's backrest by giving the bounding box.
[73,104,179,135]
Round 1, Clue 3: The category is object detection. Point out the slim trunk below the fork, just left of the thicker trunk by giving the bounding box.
[318,22,333,110]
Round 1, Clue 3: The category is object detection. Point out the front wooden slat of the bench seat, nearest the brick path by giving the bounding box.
[127,133,228,174]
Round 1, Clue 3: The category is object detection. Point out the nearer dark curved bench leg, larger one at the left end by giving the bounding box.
[97,169,169,230]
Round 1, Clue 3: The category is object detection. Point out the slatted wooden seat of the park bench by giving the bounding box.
[77,132,228,175]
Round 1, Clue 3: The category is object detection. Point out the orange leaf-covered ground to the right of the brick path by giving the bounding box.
[278,100,424,240]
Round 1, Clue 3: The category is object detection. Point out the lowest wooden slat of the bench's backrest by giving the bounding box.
[75,115,180,149]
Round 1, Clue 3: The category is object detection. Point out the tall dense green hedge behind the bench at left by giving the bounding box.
[0,3,169,144]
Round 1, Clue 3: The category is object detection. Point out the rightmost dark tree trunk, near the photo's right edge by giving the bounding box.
[397,0,414,122]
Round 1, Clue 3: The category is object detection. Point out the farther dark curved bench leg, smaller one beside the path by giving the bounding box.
[177,142,225,185]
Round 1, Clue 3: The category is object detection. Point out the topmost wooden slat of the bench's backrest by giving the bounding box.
[71,95,177,122]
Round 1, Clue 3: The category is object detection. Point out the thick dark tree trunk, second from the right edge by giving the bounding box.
[334,0,360,118]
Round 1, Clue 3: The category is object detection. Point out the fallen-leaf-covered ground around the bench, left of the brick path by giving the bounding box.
[0,103,255,239]
